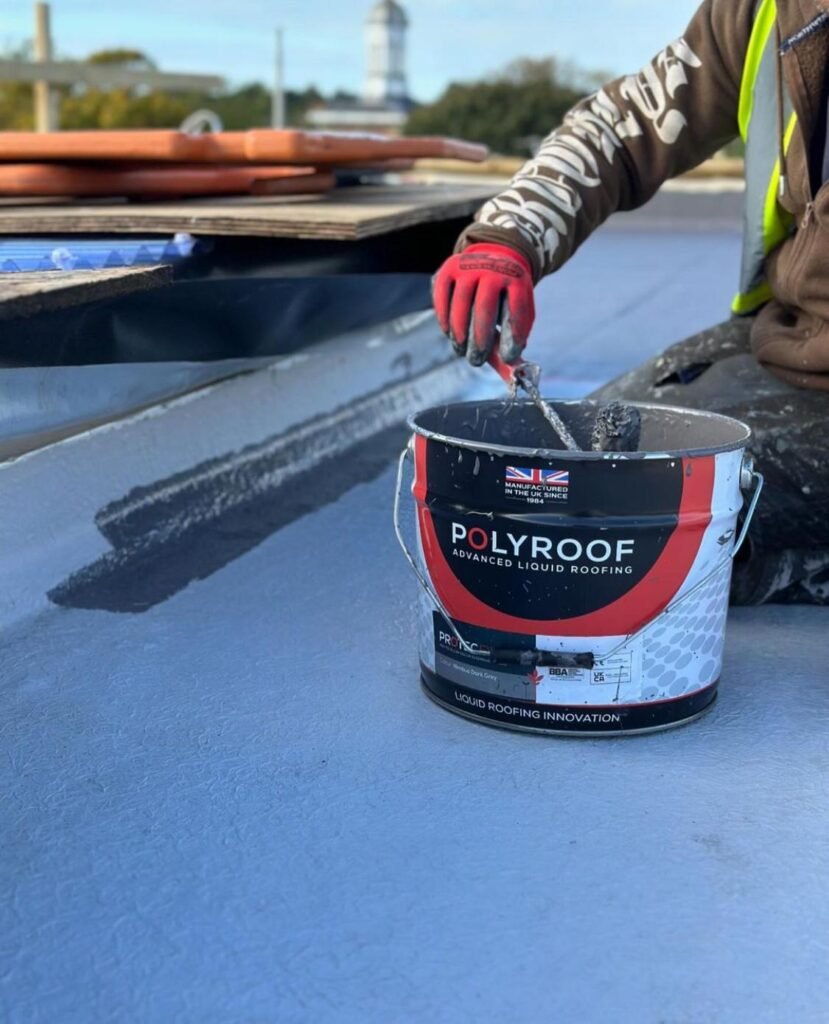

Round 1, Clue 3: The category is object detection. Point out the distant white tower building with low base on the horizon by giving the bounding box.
[307,0,413,135]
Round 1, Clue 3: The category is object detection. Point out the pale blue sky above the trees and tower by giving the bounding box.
[0,0,699,101]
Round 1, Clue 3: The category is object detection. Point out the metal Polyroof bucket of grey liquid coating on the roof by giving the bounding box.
[395,401,762,735]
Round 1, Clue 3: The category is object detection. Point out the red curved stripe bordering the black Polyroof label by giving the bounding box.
[412,434,715,637]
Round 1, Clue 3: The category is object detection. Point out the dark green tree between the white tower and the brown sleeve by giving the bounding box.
[405,57,587,156]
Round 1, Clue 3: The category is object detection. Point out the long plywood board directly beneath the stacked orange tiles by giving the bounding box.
[0,184,495,242]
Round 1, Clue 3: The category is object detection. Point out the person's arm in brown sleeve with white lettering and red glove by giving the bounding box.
[435,0,755,364]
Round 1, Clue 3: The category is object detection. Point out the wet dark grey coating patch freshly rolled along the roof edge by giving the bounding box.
[48,424,408,612]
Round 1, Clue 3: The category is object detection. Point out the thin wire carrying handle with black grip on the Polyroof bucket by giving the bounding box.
[394,441,766,669]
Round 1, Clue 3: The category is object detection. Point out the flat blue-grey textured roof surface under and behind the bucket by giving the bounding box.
[0,195,829,1024]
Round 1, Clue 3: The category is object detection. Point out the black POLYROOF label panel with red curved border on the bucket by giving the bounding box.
[416,437,714,636]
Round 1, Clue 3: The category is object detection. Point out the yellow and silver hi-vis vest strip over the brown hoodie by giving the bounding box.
[732,0,797,315]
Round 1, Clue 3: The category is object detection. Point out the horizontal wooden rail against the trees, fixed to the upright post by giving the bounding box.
[0,60,224,92]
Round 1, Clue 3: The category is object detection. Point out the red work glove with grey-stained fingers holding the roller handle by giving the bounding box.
[432,243,535,367]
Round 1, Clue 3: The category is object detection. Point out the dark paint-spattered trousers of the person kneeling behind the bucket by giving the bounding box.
[592,318,829,604]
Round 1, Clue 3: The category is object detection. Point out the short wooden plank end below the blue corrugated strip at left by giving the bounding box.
[0,265,173,321]
